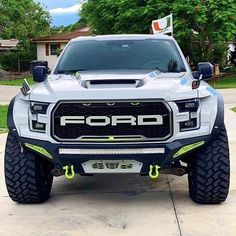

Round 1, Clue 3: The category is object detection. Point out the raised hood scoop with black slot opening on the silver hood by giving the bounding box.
[81,79,144,89]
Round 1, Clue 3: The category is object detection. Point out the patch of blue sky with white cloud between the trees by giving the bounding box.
[34,0,83,26]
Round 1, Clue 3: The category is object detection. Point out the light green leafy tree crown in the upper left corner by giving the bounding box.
[0,0,51,46]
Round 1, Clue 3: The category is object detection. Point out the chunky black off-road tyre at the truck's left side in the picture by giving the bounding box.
[4,133,53,203]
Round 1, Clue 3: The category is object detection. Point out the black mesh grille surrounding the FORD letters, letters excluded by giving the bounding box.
[52,101,172,141]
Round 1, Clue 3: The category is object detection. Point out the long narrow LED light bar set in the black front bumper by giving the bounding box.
[59,148,165,155]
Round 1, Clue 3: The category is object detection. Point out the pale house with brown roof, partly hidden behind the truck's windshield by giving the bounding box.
[31,27,90,69]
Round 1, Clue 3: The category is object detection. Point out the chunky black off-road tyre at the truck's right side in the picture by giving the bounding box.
[188,126,230,204]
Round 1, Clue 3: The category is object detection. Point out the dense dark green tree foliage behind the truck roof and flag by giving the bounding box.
[82,0,236,66]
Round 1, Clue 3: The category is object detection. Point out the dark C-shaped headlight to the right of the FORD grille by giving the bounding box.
[176,99,200,131]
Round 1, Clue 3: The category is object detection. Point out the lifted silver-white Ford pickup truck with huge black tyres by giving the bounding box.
[5,35,230,204]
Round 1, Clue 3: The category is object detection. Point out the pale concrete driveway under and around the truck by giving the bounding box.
[0,87,236,236]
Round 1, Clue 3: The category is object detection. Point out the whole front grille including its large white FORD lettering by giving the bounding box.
[51,101,172,142]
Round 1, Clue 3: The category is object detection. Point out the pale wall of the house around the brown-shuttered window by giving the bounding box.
[37,43,67,69]
